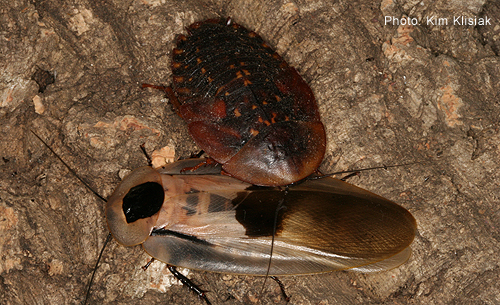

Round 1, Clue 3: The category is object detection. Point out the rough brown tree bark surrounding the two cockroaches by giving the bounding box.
[0,0,500,305]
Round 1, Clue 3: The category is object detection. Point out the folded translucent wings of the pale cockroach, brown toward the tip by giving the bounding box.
[143,176,416,275]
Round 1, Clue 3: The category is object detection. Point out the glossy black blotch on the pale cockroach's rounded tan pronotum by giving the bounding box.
[123,182,165,223]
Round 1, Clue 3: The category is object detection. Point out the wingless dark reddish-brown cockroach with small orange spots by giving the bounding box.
[162,19,326,186]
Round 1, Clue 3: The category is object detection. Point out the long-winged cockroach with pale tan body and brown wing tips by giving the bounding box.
[106,159,416,300]
